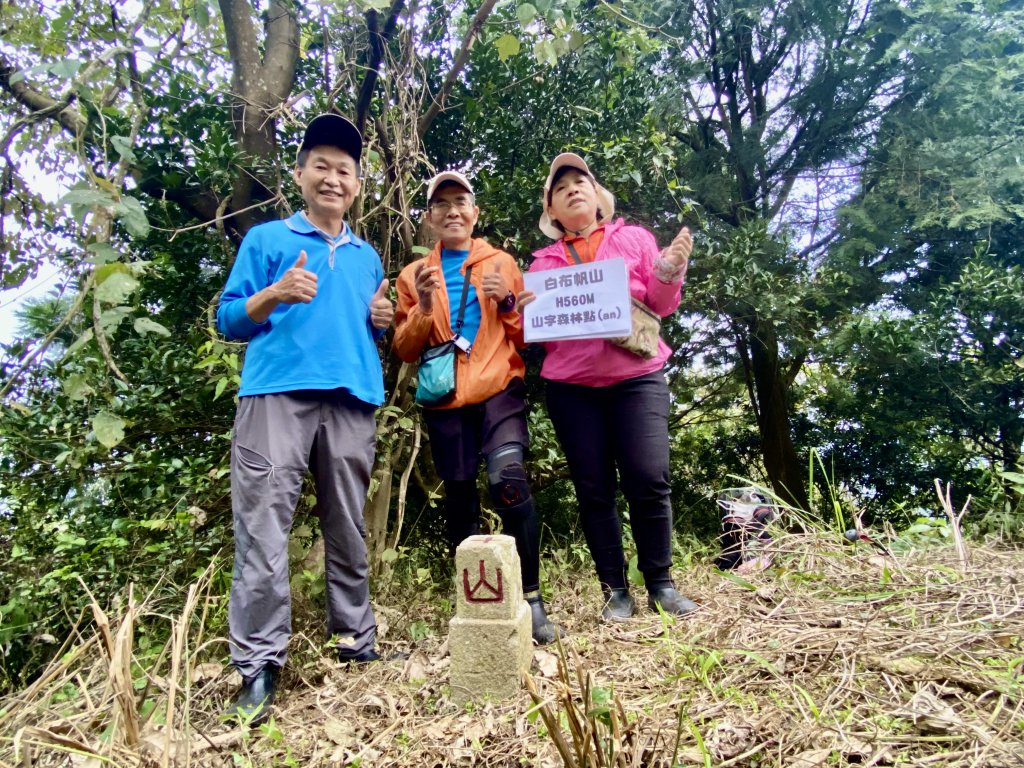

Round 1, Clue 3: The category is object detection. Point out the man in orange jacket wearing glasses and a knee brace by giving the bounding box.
[394,171,559,645]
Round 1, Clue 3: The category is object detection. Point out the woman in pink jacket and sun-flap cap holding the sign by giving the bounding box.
[519,153,697,621]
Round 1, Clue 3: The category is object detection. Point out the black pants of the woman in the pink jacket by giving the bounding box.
[547,371,672,589]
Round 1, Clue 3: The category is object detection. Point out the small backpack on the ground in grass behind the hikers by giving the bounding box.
[715,487,778,571]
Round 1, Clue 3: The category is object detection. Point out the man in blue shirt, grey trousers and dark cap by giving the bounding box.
[217,115,394,723]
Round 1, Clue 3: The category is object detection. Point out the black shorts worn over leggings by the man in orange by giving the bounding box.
[423,379,529,480]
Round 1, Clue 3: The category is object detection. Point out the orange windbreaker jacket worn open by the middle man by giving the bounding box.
[392,238,526,409]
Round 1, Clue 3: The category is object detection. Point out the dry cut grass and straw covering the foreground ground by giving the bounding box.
[0,535,1024,768]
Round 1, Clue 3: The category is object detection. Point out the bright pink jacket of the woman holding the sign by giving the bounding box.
[529,219,683,387]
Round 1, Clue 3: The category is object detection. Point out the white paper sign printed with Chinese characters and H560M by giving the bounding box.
[522,259,632,342]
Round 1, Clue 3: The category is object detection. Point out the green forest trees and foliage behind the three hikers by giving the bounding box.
[0,0,1024,689]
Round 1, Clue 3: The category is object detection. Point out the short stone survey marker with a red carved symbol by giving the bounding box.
[449,536,534,705]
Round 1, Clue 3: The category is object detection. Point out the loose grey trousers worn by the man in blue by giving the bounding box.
[227,390,377,677]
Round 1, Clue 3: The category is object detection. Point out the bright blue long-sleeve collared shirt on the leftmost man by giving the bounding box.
[217,213,384,406]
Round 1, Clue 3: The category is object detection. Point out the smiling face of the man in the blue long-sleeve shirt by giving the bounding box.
[294,144,361,234]
